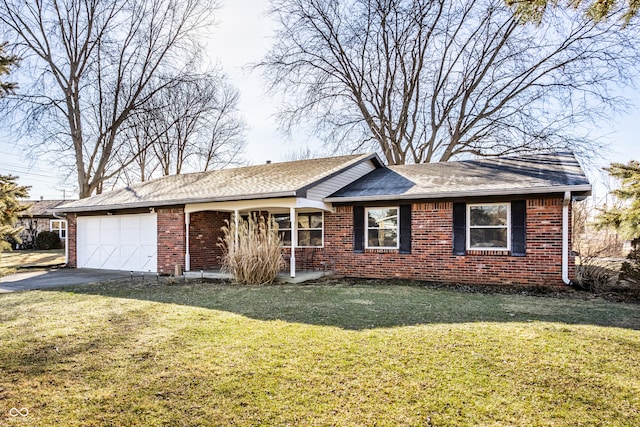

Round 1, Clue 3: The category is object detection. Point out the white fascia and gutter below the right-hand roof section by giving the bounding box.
[324,185,591,203]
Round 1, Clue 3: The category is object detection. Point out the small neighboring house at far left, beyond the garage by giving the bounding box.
[17,200,68,248]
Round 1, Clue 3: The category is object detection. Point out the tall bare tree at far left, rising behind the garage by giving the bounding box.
[0,0,217,198]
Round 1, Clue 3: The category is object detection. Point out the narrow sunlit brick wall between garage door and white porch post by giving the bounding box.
[156,207,186,274]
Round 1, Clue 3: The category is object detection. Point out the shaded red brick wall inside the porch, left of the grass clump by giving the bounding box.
[189,211,231,270]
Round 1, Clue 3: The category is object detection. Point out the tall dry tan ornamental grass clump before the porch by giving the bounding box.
[218,216,283,285]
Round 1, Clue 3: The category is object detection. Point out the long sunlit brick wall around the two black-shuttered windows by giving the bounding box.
[322,198,575,286]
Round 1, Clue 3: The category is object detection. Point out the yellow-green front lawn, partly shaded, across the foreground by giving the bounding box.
[0,283,640,426]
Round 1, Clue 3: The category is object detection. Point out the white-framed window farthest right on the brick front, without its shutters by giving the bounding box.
[467,203,511,250]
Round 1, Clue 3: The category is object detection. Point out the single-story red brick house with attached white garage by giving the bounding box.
[53,153,591,285]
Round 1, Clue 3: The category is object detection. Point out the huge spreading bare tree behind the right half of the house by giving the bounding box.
[257,0,640,164]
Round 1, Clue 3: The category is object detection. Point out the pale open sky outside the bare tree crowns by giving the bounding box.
[0,0,640,199]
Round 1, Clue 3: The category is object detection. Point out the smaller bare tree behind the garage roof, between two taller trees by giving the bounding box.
[109,72,245,188]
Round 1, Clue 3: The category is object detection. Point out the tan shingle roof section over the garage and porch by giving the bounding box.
[57,154,378,212]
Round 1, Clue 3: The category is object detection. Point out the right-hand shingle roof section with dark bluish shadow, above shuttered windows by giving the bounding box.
[325,152,591,202]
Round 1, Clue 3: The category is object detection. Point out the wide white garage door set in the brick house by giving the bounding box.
[76,213,158,272]
